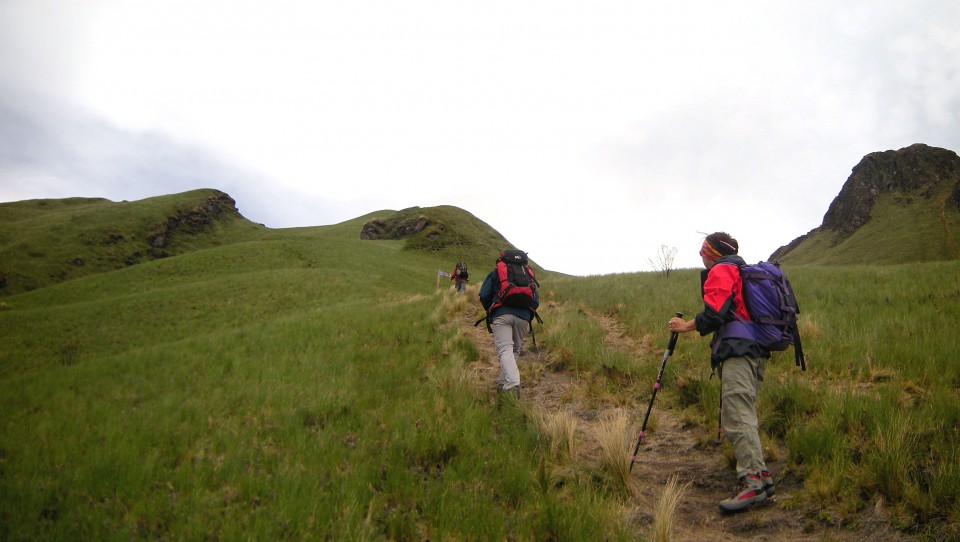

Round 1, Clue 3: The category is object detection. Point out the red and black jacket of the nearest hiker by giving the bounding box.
[694,255,770,368]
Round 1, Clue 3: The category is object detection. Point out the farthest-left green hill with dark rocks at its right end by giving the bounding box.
[0,189,264,295]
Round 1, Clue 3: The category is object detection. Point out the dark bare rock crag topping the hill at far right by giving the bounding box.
[770,143,960,261]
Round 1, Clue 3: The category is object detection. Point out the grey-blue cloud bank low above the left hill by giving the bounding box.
[0,93,350,227]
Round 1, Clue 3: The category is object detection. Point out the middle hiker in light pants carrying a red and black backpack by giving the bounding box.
[476,249,540,398]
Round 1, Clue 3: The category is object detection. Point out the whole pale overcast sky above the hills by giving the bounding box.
[0,0,960,275]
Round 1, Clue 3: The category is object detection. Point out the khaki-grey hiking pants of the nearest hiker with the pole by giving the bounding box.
[718,356,767,477]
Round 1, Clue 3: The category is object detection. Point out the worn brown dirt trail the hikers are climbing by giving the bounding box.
[462,311,913,542]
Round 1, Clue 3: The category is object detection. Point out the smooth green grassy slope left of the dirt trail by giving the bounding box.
[0,215,627,540]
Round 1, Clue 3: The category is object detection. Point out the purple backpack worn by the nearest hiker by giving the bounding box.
[740,262,807,370]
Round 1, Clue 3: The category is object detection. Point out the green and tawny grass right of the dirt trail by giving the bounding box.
[551,260,960,535]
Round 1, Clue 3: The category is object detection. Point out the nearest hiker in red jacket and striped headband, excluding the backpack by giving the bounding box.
[668,232,774,512]
